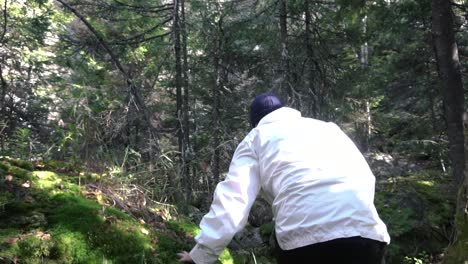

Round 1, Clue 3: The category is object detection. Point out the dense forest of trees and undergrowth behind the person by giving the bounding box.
[0,0,468,263]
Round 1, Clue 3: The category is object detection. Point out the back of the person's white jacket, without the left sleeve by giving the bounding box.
[247,107,388,254]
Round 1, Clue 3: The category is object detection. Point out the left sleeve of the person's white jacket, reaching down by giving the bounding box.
[190,140,260,264]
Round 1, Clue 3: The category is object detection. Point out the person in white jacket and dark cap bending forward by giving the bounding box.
[178,93,390,264]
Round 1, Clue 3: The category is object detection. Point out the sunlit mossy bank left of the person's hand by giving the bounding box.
[0,159,238,264]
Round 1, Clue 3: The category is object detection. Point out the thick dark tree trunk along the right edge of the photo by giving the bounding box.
[432,0,468,263]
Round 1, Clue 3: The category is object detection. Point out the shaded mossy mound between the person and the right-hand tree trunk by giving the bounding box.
[375,171,456,264]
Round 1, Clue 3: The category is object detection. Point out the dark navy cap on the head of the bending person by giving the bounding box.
[249,92,284,128]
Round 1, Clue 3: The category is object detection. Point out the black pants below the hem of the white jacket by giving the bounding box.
[278,237,386,264]
